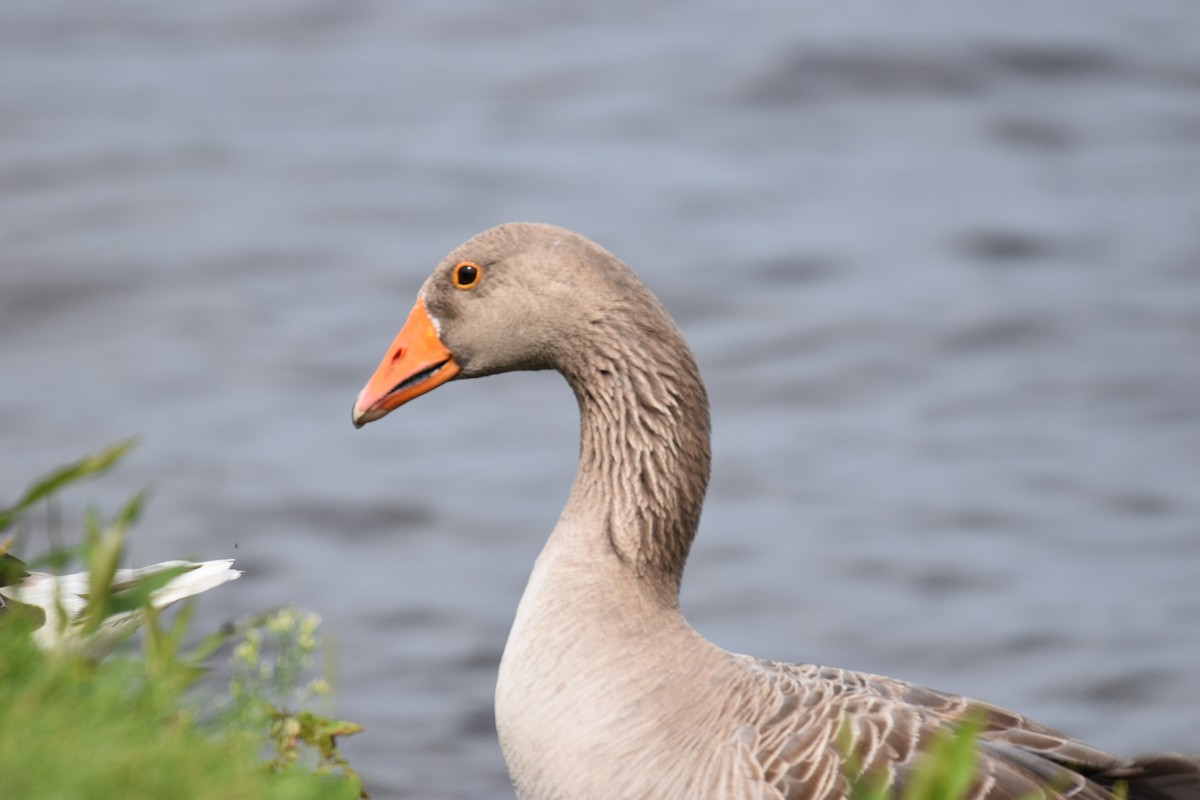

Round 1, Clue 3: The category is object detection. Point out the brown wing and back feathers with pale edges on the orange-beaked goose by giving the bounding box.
[713,658,1200,800]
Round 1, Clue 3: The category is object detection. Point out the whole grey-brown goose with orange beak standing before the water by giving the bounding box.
[353,223,1200,800]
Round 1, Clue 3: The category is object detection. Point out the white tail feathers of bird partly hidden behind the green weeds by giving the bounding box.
[0,553,241,661]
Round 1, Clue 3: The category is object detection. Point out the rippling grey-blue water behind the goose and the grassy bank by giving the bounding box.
[0,0,1200,800]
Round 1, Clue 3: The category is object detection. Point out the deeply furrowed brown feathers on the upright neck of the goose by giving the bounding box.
[564,336,709,604]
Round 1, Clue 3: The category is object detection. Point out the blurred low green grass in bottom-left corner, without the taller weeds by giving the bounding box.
[0,634,359,800]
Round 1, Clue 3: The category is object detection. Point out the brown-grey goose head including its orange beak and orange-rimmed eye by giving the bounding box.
[353,223,673,427]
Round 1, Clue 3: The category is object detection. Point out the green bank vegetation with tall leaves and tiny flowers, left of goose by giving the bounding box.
[0,443,366,800]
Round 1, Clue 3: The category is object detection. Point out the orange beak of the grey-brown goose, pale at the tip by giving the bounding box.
[353,300,458,428]
